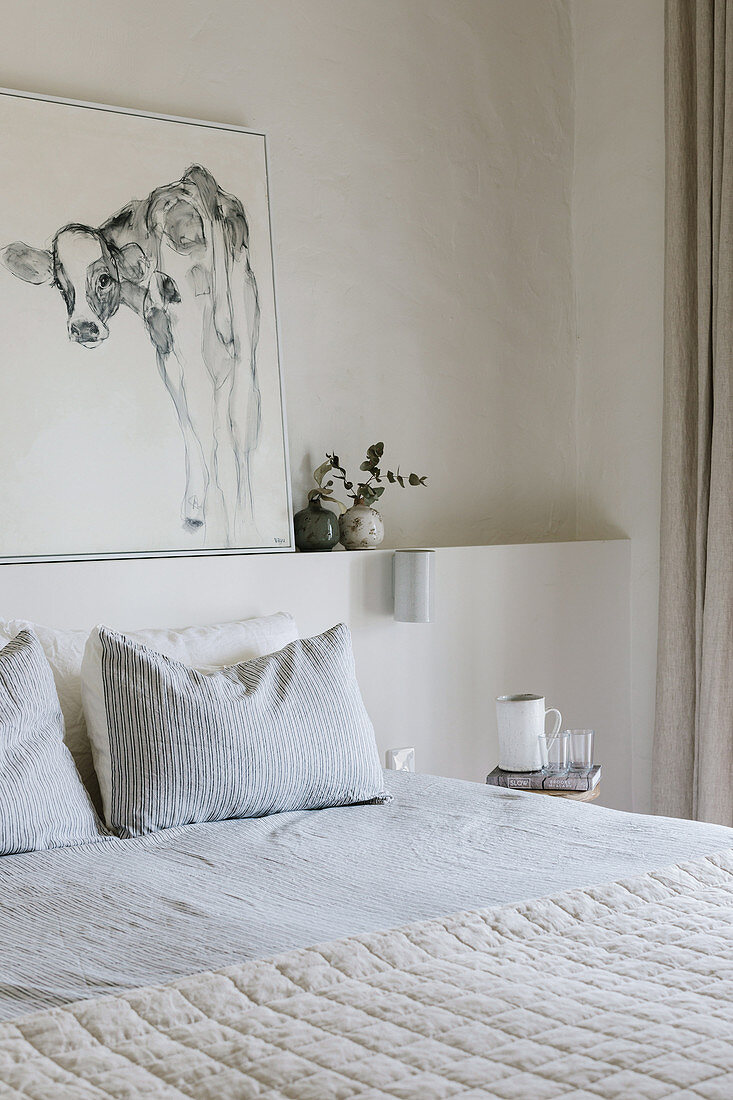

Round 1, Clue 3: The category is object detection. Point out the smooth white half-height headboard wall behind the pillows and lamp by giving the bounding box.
[0,540,631,809]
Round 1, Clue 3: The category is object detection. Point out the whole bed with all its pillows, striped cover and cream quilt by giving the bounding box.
[0,614,733,1100]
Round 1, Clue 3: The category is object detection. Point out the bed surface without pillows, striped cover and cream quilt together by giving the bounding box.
[0,772,733,1098]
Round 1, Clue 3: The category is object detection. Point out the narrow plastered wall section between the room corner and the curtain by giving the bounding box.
[572,0,665,811]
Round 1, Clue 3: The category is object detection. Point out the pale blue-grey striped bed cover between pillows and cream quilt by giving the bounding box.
[0,772,733,1019]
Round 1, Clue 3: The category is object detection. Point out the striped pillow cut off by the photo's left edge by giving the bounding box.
[0,630,103,856]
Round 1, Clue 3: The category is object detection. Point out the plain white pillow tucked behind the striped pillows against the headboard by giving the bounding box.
[0,612,298,810]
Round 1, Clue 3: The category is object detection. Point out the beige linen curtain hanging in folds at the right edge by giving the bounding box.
[654,0,733,825]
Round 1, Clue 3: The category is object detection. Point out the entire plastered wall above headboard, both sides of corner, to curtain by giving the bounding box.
[0,0,664,809]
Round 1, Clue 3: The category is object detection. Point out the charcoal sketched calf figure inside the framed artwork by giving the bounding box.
[0,165,261,546]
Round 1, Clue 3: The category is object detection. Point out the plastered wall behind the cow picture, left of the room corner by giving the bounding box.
[0,0,575,546]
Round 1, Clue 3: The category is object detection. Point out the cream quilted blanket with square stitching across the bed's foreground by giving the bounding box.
[0,851,733,1100]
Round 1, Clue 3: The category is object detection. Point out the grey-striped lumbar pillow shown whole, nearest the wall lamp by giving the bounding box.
[81,625,389,836]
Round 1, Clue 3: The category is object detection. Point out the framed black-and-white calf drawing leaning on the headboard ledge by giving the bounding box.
[0,91,294,561]
